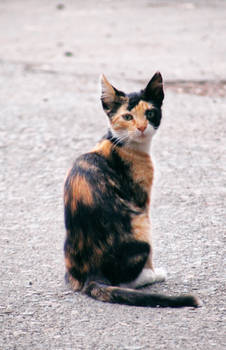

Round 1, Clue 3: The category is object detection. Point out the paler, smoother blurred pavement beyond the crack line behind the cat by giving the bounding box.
[0,0,225,81]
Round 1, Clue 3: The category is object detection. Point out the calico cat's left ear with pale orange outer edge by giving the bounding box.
[100,74,126,117]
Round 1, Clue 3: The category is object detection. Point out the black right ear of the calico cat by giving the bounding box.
[144,72,164,107]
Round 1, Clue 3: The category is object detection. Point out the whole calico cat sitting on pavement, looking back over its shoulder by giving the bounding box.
[64,72,200,307]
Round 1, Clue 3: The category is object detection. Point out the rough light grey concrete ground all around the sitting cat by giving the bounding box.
[0,0,226,350]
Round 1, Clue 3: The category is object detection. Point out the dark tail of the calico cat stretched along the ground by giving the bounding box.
[83,281,201,307]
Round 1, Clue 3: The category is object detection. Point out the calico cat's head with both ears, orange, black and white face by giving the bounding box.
[101,72,164,150]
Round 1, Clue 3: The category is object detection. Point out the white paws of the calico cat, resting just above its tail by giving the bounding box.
[120,269,166,289]
